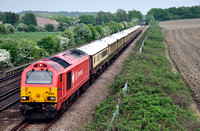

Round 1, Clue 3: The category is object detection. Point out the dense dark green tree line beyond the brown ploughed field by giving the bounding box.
[146,6,200,23]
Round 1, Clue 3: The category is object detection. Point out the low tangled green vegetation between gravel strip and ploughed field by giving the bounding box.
[85,26,200,130]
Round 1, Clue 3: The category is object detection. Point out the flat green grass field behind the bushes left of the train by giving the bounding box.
[0,32,58,43]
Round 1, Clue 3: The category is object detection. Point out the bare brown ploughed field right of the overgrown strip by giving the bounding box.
[160,19,200,109]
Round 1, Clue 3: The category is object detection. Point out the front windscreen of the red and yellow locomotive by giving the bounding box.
[26,70,53,84]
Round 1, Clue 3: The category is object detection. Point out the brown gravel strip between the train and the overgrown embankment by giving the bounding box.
[50,26,147,131]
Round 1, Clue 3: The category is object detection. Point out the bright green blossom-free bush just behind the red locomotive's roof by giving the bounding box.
[37,36,62,54]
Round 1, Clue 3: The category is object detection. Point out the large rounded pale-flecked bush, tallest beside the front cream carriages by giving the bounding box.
[73,23,92,45]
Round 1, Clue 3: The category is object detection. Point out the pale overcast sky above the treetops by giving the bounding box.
[0,0,200,14]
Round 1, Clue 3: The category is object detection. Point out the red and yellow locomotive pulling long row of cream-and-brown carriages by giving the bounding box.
[19,25,142,119]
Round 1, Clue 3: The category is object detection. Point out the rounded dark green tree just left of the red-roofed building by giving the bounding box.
[22,13,37,26]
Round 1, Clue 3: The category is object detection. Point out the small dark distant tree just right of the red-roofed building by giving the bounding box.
[79,15,96,25]
